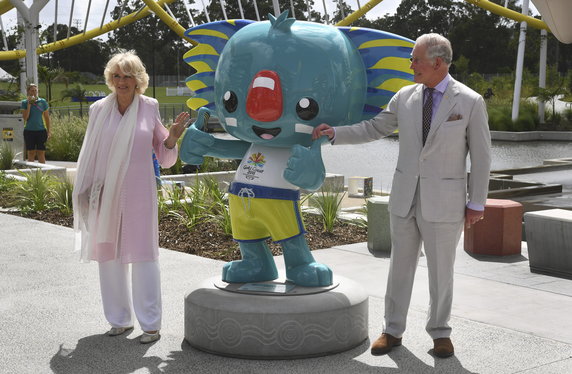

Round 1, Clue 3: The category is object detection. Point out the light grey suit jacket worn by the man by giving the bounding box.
[334,79,491,222]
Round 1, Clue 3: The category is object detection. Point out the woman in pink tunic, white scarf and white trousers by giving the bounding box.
[73,51,189,343]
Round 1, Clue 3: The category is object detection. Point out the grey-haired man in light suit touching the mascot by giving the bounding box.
[313,34,490,358]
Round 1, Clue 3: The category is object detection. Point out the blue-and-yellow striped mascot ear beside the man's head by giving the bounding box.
[338,27,415,119]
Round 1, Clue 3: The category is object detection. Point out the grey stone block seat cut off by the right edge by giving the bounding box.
[524,209,572,279]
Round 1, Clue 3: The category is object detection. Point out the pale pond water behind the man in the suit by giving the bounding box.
[322,138,572,191]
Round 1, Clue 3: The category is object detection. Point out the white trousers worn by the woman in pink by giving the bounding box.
[99,259,162,331]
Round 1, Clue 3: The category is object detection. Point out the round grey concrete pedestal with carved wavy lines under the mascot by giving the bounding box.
[185,277,368,359]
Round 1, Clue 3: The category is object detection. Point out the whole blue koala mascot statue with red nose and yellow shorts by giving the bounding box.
[180,12,413,287]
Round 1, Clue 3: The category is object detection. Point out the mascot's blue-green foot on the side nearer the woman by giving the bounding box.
[222,260,278,283]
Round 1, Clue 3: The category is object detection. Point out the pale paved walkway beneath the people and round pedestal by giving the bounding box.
[0,214,572,374]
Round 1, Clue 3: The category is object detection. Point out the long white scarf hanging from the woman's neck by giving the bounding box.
[72,93,139,262]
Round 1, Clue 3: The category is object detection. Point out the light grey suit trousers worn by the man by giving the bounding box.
[384,187,464,339]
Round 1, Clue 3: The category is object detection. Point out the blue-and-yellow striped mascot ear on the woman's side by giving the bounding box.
[183,20,254,110]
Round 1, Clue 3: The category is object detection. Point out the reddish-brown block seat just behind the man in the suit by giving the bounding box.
[464,199,523,256]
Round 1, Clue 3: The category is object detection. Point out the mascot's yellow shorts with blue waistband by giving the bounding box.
[228,182,306,242]
